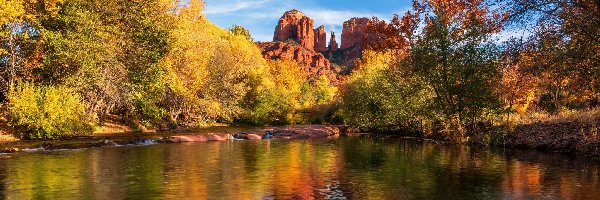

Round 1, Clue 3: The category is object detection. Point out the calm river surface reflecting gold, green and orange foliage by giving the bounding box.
[0,136,600,199]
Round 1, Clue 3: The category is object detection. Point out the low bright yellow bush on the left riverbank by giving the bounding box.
[8,83,93,139]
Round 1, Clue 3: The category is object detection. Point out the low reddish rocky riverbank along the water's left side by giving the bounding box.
[0,125,349,153]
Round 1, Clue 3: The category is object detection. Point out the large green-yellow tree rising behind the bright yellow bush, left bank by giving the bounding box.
[34,0,173,124]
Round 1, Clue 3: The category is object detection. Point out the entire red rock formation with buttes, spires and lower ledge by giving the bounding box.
[258,10,376,84]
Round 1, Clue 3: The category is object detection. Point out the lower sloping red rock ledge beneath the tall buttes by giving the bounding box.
[258,42,338,84]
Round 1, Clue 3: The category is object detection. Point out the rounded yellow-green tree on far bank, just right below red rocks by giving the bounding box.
[342,51,433,132]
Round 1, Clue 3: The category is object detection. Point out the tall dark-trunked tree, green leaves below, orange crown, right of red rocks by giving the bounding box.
[405,0,506,139]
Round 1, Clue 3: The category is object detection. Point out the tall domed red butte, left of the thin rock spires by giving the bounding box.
[273,10,315,50]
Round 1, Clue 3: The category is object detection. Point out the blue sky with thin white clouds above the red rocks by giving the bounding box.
[204,0,412,43]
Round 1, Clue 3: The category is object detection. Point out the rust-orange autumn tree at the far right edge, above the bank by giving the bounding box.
[509,0,600,113]
